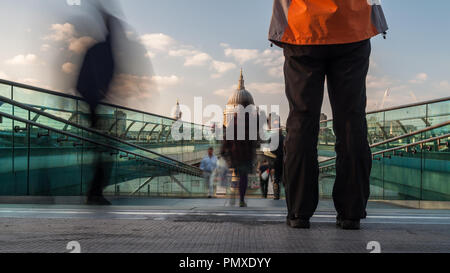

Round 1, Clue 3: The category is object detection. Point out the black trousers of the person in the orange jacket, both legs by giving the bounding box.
[283,40,372,220]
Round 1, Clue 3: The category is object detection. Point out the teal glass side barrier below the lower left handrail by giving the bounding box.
[0,112,201,195]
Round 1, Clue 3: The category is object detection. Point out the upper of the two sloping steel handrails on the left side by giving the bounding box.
[0,96,200,171]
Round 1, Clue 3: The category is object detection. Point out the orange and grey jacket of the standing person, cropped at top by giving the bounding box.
[269,0,388,46]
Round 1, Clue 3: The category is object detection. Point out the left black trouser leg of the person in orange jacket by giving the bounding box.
[283,45,326,219]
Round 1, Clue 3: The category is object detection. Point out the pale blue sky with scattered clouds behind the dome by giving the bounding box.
[0,0,450,122]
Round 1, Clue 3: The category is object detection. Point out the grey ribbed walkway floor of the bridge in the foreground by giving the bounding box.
[0,199,450,253]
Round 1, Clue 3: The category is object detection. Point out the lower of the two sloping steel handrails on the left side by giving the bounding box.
[0,112,201,177]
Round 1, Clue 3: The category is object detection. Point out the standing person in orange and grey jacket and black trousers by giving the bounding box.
[269,0,388,229]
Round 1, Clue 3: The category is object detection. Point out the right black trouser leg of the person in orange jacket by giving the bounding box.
[327,40,372,220]
